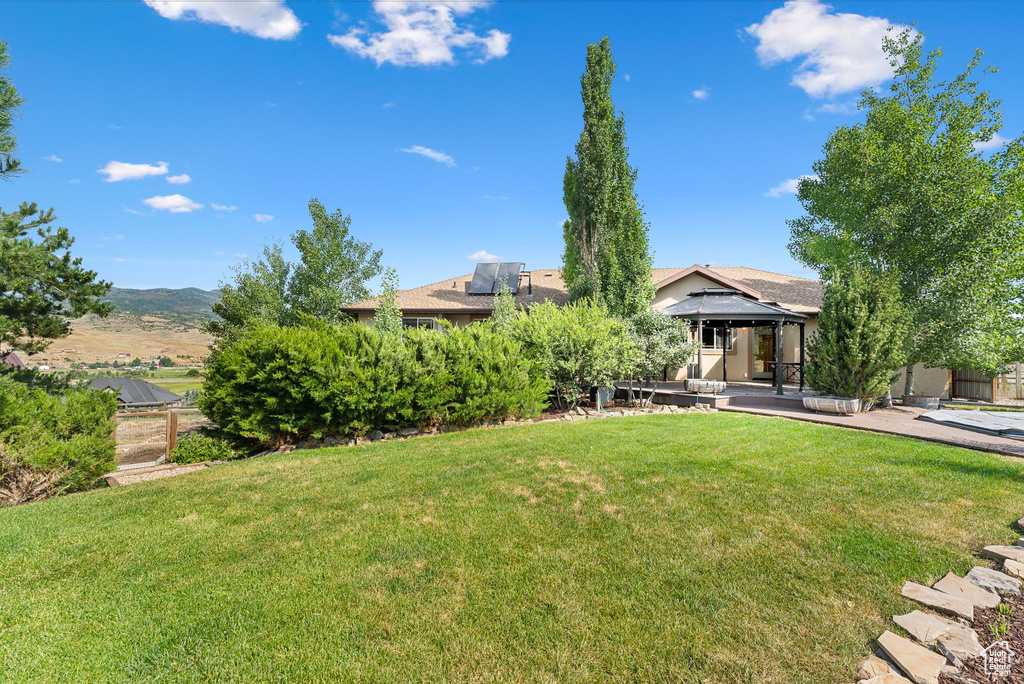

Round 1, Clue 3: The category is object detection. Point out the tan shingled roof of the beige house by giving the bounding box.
[342,265,821,314]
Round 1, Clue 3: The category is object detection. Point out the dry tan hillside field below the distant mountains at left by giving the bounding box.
[22,315,212,369]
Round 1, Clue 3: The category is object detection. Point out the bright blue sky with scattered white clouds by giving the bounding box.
[0,0,1024,289]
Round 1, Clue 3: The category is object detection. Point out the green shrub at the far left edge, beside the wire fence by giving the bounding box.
[0,380,117,494]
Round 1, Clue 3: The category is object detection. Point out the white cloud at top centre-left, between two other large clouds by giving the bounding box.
[327,0,512,67]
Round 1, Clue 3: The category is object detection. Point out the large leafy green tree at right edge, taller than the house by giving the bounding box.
[788,32,1024,394]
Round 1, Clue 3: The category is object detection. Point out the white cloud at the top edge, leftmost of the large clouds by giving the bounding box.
[144,0,302,40]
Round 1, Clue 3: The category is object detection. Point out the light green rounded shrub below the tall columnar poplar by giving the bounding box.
[503,300,636,405]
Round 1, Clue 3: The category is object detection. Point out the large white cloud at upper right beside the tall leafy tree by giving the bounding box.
[746,0,913,97]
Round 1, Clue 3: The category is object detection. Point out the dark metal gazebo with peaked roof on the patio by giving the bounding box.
[662,288,807,394]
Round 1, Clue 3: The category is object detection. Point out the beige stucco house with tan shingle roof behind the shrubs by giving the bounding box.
[342,262,950,397]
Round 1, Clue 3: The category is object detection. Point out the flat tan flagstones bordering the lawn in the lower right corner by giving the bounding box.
[857,518,1024,684]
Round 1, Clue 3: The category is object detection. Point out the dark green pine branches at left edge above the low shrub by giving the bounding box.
[0,203,113,354]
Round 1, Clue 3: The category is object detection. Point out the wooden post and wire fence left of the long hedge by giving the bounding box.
[114,409,210,469]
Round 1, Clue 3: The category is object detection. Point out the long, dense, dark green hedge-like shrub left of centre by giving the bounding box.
[200,322,549,443]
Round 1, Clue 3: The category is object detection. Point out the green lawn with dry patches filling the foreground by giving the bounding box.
[0,414,1024,683]
